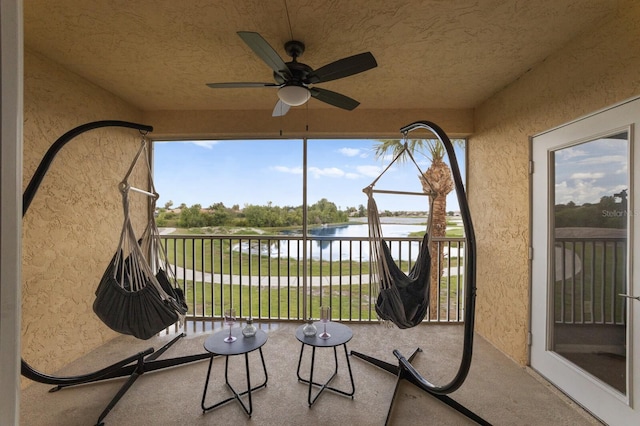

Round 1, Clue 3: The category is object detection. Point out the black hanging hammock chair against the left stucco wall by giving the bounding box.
[93,139,187,339]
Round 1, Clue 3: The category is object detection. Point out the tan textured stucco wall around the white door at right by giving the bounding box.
[469,1,640,364]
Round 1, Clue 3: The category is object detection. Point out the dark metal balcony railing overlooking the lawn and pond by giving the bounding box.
[162,235,464,323]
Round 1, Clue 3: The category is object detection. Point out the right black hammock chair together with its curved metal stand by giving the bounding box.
[351,121,491,425]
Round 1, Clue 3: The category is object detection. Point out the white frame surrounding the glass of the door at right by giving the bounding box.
[530,99,640,425]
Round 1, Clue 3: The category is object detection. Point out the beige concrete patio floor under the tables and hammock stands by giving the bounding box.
[20,323,600,426]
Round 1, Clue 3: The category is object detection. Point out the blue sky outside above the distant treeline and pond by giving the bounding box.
[154,139,464,211]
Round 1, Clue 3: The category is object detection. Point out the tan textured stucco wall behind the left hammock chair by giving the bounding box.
[22,50,146,380]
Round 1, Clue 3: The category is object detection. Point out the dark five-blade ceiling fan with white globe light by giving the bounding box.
[207,31,378,117]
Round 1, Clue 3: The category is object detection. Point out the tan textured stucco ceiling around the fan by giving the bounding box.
[24,0,616,110]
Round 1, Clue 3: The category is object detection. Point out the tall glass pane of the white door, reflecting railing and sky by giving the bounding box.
[550,132,631,394]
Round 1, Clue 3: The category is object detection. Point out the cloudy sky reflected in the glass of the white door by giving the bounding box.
[555,134,629,205]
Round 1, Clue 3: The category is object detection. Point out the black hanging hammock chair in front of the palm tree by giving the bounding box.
[362,138,435,329]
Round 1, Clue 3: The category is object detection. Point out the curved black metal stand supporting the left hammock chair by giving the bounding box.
[21,120,211,425]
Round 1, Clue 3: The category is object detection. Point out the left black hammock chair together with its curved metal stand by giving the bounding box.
[21,120,211,425]
